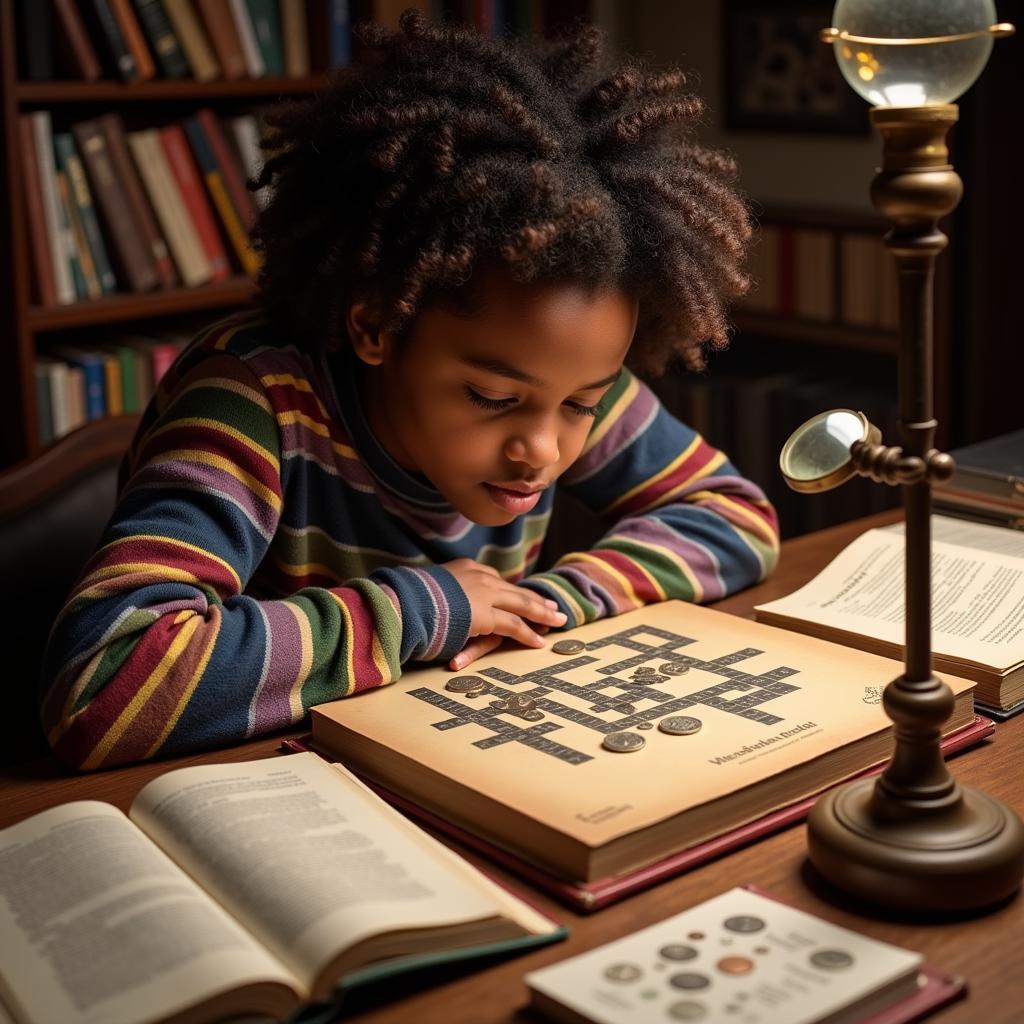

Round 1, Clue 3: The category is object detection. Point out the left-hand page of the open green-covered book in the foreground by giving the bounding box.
[0,801,296,1024]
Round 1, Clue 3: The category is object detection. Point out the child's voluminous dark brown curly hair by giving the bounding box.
[254,10,751,375]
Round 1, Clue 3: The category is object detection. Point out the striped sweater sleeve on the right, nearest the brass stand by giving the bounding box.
[524,373,778,627]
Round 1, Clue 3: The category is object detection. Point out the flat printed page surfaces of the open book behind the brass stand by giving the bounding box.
[757,524,1024,672]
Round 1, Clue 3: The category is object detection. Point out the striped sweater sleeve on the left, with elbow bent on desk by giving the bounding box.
[42,353,469,769]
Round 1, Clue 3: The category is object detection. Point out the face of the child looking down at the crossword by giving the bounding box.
[353,272,637,526]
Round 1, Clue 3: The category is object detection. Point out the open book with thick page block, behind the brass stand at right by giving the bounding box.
[756,516,1024,712]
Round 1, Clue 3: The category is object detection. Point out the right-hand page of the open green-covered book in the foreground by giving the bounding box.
[131,754,520,987]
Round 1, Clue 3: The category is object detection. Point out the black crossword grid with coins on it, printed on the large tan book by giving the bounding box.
[421,625,799,765]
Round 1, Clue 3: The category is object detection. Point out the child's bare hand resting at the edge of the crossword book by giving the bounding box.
[444,558,565,669]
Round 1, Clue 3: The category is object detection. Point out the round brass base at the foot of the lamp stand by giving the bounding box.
[807,779,1024,913]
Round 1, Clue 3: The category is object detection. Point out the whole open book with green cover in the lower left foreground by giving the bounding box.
[0,754,565,1024]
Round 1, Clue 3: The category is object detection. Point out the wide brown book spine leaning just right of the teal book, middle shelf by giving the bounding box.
[72,121,160,292]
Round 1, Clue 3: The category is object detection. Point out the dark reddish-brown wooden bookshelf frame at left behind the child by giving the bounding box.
[0,0,590,466]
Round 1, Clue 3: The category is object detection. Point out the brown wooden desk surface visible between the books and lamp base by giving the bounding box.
[0,513,1024,1024]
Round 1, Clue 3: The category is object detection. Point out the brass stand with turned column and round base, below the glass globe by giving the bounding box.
[808,104,1024,911]
